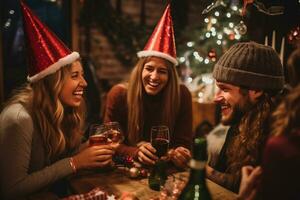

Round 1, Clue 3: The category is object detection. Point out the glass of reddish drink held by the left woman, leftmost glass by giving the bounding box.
[89,124,110,146]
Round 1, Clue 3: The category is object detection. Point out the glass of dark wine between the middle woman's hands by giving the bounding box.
[151,126,170,158]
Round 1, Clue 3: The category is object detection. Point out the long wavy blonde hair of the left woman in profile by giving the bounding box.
[7,65,85,161]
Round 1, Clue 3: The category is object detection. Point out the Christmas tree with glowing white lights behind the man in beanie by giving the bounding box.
[178,0,247,79]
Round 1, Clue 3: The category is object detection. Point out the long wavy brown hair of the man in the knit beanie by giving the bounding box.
[226,89,276,177]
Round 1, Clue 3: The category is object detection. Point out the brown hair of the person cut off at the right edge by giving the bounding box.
[271,85,300,136]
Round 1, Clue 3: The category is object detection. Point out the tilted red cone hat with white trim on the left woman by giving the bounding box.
[20,1,79,82]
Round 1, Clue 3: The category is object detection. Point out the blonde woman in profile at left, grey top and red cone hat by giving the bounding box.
[0,3,114,199]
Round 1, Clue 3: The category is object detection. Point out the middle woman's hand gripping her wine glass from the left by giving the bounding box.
[137,142,158,165]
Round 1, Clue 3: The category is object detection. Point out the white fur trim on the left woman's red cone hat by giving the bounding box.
[27,51,80,83]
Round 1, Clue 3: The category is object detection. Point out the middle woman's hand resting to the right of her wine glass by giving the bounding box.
[168,147,191,168]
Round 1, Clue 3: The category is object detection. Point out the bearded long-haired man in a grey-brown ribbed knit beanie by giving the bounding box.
[206,42,284,192]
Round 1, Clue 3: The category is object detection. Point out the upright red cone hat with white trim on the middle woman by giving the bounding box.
[137,4,178,65]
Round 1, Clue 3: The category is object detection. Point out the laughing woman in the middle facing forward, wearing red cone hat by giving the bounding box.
[104,3,193,167]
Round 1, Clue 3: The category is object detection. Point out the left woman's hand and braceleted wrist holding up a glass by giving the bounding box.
[73,145,115,170]
